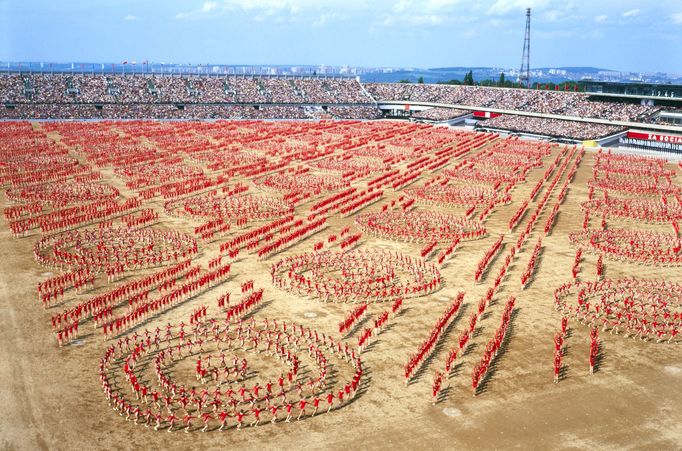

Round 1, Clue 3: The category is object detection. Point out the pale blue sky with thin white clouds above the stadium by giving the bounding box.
[0,0,682,73]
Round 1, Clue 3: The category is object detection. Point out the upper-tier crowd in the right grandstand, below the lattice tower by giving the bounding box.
[365,83,660,122]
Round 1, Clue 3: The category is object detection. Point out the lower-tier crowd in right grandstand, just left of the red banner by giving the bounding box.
[478,114,625,141]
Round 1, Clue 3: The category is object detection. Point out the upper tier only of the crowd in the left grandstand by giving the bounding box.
[0,73,375,105]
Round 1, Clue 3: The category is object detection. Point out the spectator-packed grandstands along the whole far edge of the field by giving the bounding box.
[0,72,682,154]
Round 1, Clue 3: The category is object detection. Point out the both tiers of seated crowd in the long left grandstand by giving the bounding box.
[0,73,381,119]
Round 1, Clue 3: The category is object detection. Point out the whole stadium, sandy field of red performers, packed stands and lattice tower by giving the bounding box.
[0,2,682,450]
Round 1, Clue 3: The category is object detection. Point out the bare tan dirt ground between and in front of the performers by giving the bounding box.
[0,122,682,450]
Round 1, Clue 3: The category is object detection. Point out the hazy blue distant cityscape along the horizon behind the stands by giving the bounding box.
[0,61,682,84]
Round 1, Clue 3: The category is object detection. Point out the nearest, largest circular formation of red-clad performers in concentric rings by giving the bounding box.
[99,318,363,432]
